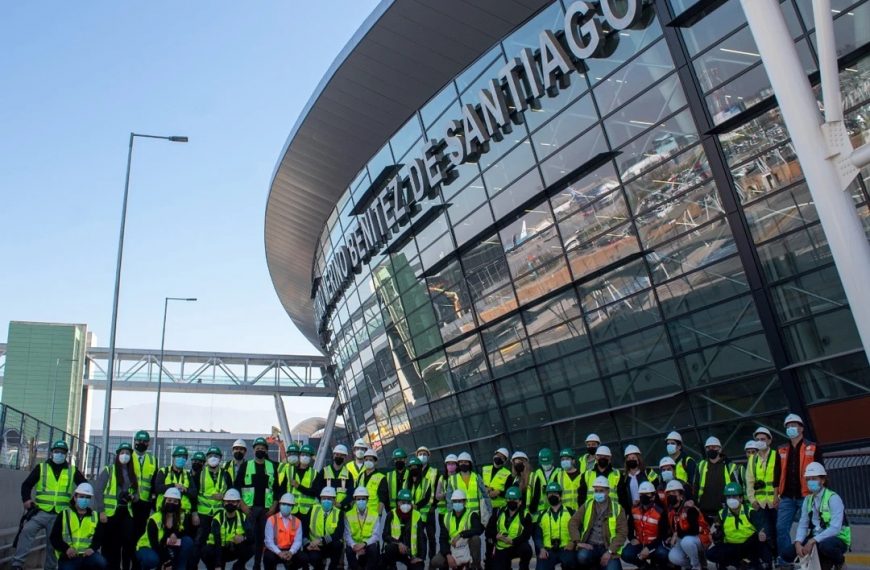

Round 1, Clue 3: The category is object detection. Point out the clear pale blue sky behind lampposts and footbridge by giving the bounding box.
[0,0,377,431]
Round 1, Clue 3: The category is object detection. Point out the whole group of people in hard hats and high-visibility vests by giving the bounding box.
[13,414,851,570]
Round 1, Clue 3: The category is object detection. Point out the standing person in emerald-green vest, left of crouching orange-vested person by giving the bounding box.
[233,437,281,570]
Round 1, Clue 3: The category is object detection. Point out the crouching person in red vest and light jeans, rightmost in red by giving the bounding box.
[665,479,712,570]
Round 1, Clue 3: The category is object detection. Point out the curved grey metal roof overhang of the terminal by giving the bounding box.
[265,0,552,348]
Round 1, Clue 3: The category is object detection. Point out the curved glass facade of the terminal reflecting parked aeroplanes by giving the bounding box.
[312,0,870,457]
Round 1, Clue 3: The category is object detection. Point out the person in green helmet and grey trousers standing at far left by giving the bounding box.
[12,440,87,570]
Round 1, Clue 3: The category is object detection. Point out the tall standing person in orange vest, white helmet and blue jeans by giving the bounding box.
[776,414,823,562]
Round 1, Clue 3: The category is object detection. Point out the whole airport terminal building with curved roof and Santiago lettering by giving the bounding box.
[265,0,870,461]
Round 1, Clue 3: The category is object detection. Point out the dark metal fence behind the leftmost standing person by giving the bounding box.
[0,404,100,479]
